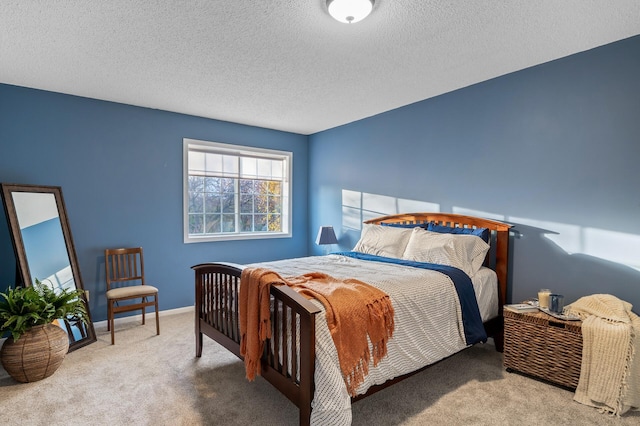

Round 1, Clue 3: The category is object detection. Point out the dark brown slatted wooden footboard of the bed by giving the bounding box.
[192,263,320,425]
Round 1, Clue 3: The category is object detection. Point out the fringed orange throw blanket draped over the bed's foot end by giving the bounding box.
[240,268,394,396]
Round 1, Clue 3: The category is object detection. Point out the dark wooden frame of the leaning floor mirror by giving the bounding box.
[1,183,96,352]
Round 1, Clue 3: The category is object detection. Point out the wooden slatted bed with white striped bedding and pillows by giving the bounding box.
[193,213,510,425]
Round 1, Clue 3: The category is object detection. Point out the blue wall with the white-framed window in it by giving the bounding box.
[0,84,308,321]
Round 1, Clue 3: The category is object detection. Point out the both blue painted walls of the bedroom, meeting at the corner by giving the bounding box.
[0,37,640,320]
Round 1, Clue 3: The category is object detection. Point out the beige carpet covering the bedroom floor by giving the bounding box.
[0,313,640,426]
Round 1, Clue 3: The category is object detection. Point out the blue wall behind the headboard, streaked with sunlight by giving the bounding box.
[309,36,640,312]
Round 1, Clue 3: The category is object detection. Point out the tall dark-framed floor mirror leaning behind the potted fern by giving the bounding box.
[2,183,96,351]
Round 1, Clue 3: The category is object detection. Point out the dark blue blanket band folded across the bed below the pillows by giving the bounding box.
[332,251,487,345]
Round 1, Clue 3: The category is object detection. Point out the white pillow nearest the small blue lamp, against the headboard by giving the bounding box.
[353,223,412,259]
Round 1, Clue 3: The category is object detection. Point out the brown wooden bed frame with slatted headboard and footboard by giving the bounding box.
[192,213,511,425]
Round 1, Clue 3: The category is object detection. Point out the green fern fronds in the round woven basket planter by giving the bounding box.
[0,279,89,341]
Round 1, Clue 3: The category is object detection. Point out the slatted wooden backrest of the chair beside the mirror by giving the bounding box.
[104,247,145,290]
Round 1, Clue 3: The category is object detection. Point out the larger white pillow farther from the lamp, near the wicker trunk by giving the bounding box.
[402,228,489,277]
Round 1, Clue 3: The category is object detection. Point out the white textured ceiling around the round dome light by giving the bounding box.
[0,0,640,134]
